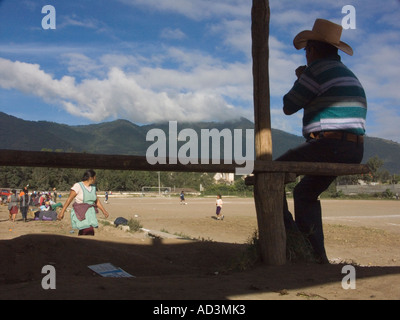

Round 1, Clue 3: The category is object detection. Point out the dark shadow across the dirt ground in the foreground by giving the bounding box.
[0,235,400,300]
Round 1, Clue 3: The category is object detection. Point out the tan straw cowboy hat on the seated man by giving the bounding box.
[293,19,353,56]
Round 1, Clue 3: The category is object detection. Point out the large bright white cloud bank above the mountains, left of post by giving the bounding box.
[0,57,248,123]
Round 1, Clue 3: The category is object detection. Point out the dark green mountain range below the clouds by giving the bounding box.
[0,112,400,174]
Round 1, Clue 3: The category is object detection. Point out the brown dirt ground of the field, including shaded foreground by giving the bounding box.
[0,197,400,300]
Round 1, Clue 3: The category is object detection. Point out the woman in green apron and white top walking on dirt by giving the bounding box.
[58,170,109,236]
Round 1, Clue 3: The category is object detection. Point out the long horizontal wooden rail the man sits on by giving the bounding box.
[0,150,370,176]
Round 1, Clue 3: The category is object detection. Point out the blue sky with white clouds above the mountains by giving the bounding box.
[0,0,400,142]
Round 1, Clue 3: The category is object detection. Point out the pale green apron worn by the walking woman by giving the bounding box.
[71,182,99,230]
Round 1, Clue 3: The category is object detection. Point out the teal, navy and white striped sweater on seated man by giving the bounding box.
[283,56,367,138]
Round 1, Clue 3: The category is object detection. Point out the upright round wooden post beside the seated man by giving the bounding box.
[252,0,286,265]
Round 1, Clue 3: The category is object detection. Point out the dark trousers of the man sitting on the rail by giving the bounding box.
[276,138,364,259]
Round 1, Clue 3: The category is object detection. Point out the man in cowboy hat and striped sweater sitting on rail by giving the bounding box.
[276,19,367,263]
